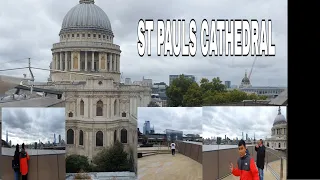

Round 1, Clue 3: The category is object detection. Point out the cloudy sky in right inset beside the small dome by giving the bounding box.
[202,106,287,139]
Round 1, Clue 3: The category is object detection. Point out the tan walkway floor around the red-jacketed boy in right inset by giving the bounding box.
[223,160,287,180]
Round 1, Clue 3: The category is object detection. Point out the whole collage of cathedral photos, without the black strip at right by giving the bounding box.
[0,0,288,180]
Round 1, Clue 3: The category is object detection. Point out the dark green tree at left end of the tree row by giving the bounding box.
[166,74,193,107]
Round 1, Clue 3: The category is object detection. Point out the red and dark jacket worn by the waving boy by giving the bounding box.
[232,155,259,180]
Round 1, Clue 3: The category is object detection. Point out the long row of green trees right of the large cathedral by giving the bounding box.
[166,74,267,107]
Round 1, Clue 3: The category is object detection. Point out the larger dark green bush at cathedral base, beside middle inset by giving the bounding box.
[93,141,132,172]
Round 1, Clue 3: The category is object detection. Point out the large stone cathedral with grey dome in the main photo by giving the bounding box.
[42,0,151,164]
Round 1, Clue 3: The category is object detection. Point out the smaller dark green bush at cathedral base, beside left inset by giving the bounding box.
[66,154,90,173]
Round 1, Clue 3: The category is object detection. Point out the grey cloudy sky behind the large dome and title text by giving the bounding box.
[0,0,287,86]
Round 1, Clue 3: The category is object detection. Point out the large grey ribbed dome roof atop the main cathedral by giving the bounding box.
[60,0,113,36]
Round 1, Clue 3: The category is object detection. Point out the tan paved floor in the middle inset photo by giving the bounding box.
[138,154,202,180]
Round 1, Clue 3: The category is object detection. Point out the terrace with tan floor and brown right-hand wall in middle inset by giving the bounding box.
[138,141,202,180]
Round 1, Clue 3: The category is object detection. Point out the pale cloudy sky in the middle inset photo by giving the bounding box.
[138,107,202,135]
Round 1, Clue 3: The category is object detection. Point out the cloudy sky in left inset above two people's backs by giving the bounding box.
[2,108,65,144]
